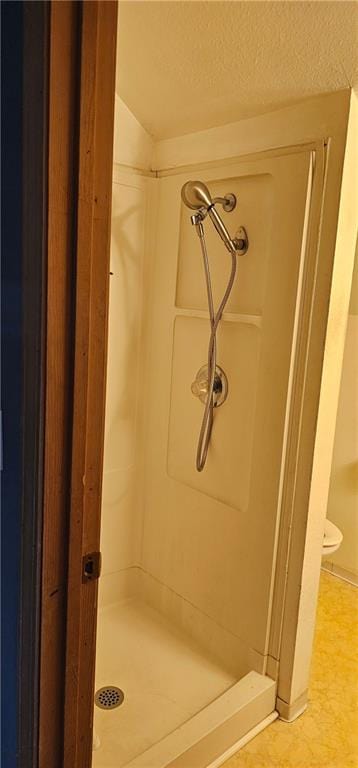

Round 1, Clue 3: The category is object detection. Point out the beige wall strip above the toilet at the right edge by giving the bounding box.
[326,240,358,576]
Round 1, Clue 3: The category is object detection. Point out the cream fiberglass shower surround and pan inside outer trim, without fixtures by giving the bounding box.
[93,151,313,768]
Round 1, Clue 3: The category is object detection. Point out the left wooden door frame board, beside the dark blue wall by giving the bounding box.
[39,0,79,768]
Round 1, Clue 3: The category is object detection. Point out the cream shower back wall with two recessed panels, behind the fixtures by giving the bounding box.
[141,151,312,674]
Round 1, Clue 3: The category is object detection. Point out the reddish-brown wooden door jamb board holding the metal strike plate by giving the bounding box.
[63,0,117,768]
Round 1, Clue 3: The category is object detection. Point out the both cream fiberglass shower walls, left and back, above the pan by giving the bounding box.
[100,103,312,678]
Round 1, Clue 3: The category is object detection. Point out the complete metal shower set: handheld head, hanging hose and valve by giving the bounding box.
[181,181,249,472]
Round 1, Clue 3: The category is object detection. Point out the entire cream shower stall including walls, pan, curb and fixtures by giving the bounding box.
[88,22,356,768]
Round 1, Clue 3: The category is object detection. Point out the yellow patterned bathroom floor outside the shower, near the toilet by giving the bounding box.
[223,571,358,768]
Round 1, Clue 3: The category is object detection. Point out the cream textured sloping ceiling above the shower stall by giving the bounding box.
[116,0,358,139]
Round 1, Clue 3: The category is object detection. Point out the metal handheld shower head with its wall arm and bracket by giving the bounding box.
[181,181,249,255]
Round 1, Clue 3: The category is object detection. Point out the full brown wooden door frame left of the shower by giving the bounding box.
[37,0,117,768]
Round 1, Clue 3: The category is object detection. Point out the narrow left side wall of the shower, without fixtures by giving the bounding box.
[100,166,150,600]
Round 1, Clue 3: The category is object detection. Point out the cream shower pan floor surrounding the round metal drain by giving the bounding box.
[92,600,236,768]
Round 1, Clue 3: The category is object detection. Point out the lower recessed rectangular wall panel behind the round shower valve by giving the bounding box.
[168,316,261,514]
